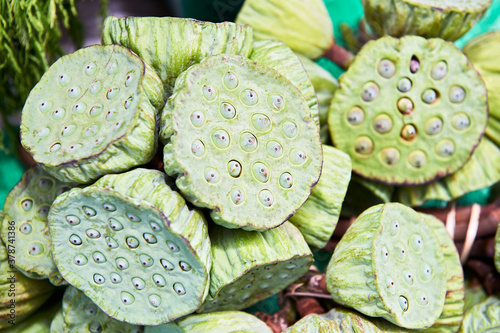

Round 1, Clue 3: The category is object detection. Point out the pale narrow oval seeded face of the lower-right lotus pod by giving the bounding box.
[372,204,446,328]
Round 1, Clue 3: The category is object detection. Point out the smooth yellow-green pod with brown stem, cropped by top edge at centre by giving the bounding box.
[236,0,333,59]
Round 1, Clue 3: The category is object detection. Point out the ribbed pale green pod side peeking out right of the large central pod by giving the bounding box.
[288,145,352,249]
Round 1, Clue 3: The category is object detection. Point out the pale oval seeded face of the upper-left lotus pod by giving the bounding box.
[21,45,145,166]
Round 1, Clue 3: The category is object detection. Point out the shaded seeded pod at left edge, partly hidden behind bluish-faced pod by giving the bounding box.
[1,166,74,285]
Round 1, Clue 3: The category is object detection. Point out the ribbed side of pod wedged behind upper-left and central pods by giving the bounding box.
[101,16,253,96]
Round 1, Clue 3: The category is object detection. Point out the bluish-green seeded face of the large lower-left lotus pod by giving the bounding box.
[49,188,207,325]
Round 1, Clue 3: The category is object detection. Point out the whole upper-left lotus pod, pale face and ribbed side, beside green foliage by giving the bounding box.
[21,45,163,183]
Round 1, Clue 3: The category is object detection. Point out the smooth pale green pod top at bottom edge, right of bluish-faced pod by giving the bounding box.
[144,311,273,333]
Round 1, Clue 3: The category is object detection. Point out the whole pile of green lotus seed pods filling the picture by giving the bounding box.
[0,0,500,333]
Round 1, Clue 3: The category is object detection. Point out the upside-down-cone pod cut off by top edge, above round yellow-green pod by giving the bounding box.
[362,0,492,41]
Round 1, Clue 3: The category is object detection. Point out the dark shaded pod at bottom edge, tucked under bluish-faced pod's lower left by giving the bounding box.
[63,286,144,333]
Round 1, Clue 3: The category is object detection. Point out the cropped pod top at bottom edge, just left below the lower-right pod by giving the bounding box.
[283,308,382,333]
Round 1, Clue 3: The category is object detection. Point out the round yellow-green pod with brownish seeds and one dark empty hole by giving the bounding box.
[328,36,488,185]
